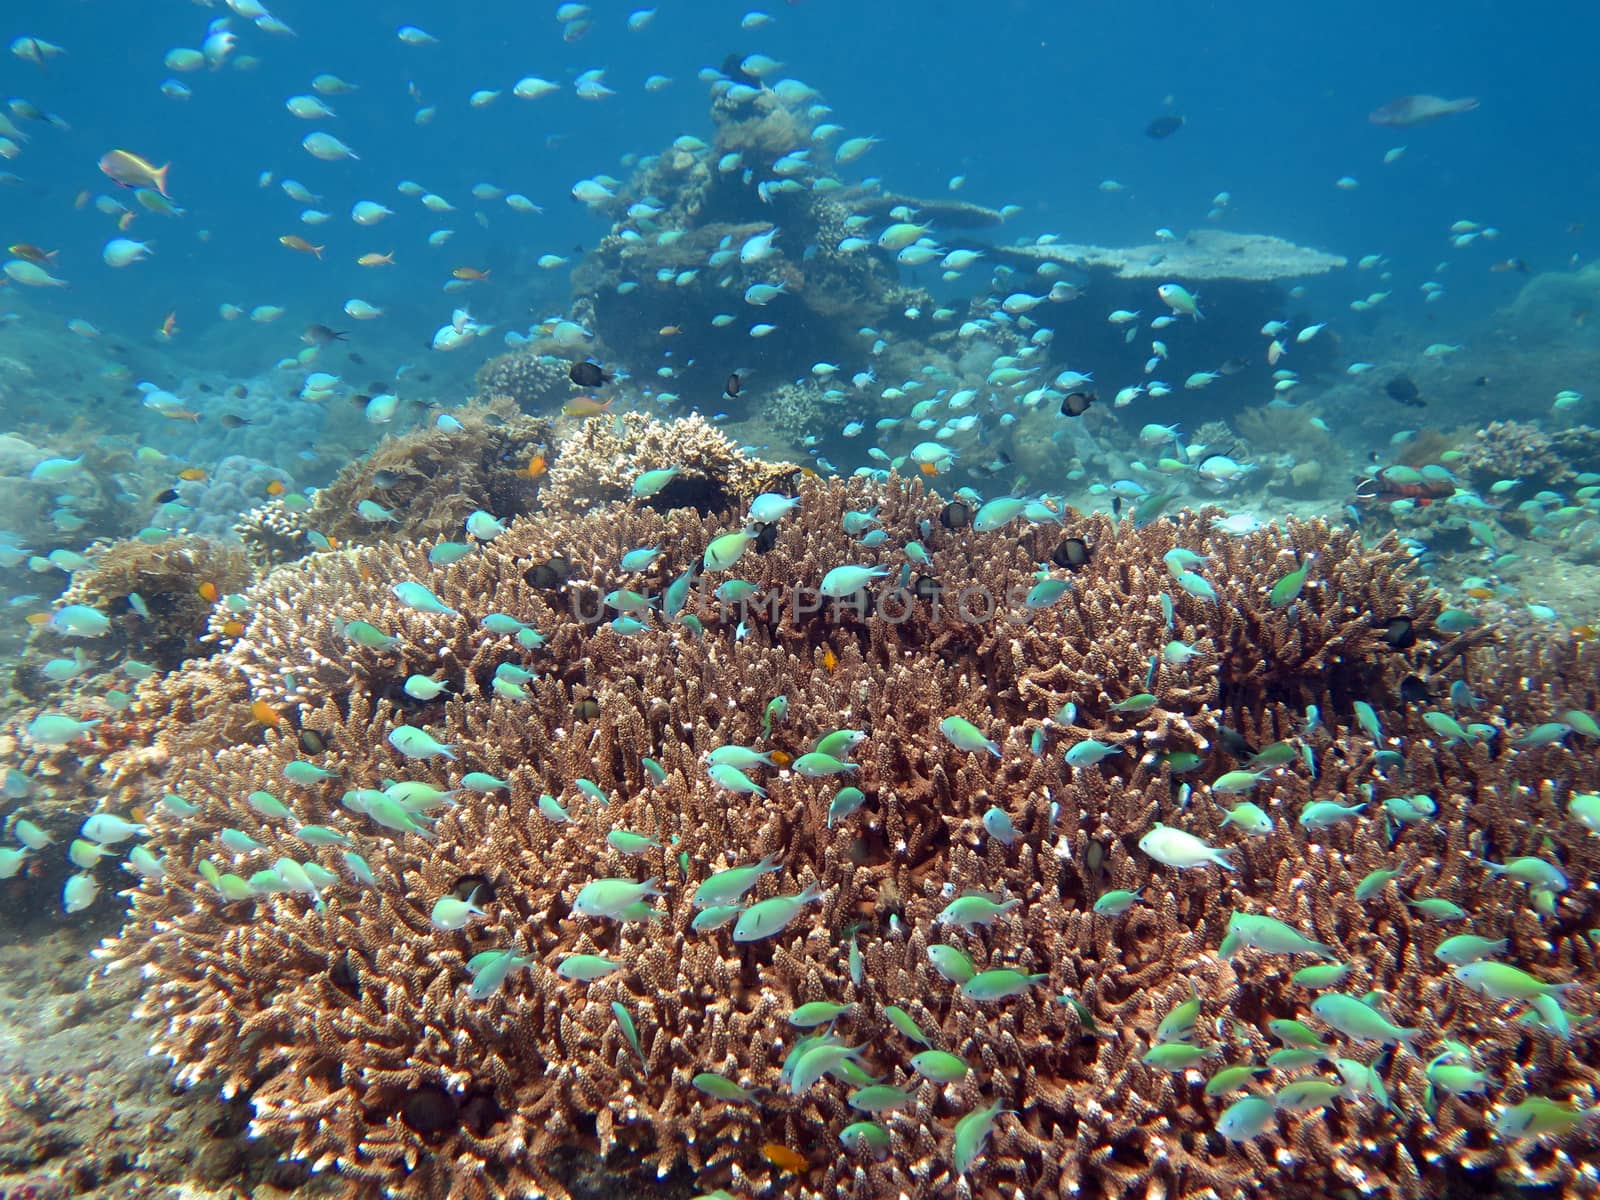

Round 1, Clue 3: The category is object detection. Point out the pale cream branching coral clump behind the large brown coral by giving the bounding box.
[542,413,800,514]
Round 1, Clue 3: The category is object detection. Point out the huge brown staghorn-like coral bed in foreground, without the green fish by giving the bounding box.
[93,464,1600,1200]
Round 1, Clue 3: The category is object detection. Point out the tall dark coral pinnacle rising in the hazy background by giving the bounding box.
[573,90,934,413]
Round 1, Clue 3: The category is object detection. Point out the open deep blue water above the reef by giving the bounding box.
[0,0,1600,365]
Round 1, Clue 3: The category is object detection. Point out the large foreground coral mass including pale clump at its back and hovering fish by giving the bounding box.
[3,416,1600,1200]
